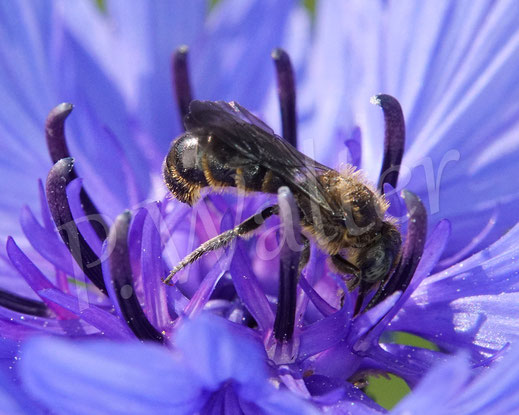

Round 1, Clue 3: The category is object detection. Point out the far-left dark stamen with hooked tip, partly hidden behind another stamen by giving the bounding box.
[45,102,108,241]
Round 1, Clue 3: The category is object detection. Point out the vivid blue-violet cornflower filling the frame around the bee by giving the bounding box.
[0,0,519,414]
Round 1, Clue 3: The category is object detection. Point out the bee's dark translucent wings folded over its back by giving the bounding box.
[184,101,337,213]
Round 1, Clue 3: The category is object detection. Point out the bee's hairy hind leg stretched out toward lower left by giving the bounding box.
[163,205,279,284]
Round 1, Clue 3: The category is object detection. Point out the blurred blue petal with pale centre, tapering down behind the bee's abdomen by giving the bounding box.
[65,0,208,161]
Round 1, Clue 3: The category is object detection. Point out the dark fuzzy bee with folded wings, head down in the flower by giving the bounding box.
[163,101,401,308]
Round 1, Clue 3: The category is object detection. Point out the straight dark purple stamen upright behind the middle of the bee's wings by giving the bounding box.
[272,48,297,147]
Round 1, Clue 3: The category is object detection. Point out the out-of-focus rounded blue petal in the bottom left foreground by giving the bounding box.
[20,338,207,414]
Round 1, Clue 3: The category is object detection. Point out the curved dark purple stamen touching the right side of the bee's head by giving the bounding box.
[368,190,427,308]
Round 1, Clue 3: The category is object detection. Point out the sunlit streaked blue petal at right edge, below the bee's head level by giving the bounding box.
[391,221,519,353]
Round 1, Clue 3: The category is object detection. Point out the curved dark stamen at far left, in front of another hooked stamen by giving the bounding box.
[45,157,106,294]
